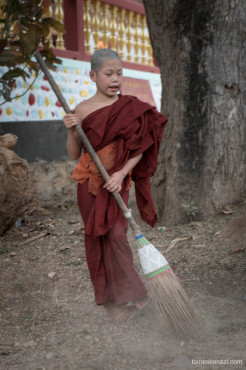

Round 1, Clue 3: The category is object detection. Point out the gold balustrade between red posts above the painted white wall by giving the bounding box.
[38,0,153,66]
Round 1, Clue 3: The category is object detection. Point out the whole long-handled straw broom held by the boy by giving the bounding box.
[34,51,200,339]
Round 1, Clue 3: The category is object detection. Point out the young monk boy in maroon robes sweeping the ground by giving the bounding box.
[64,49,167,321]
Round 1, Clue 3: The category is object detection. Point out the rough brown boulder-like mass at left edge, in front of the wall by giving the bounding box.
[0,134,38,235]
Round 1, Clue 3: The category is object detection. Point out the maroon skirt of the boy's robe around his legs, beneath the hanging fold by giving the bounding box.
[78,180,147,305]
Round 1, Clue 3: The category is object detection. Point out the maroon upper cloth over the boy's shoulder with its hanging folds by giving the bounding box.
[71,95,167,238]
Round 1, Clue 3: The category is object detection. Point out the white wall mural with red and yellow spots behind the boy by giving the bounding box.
[0,59,161,122]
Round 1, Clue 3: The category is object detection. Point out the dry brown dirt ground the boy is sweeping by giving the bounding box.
[0,200,246,370]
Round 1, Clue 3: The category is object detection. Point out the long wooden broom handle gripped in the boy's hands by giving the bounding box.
[34,51,141,236]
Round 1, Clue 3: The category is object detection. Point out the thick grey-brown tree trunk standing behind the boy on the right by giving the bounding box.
[144,0,246,224]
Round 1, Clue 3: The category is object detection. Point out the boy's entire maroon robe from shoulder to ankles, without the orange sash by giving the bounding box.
[77,95,167,305]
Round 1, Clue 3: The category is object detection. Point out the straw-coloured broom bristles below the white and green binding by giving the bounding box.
[148,269,200,339]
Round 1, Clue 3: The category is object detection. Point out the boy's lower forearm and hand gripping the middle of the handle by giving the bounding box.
[103,153,143,193]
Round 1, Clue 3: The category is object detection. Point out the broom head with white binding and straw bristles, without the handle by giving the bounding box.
[135,234,200,339]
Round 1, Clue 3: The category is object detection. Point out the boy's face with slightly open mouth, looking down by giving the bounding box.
[90,59,122,97]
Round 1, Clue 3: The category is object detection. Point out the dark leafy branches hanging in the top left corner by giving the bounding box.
[0,0,64,101]
